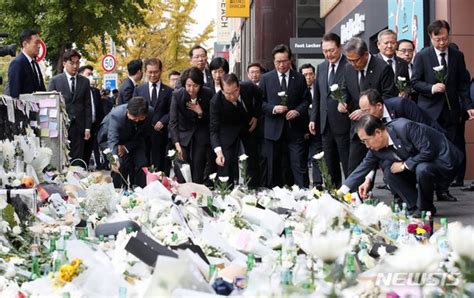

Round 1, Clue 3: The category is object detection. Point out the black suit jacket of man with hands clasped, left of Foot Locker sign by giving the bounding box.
[259,70,311,141]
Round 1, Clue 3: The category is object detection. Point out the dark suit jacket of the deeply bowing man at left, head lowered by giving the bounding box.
[97,105,153,154]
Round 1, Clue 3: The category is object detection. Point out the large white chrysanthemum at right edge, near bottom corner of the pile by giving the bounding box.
[448,225,474,260]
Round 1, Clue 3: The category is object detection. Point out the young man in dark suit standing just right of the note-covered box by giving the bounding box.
[48,50,92,165]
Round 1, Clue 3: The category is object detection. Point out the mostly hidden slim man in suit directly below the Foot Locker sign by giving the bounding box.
[299,63,323,188]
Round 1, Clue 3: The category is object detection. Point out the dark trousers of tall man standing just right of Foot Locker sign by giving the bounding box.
[322,127,350,188]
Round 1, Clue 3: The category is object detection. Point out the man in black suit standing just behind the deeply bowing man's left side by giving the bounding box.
[78,65,105,169]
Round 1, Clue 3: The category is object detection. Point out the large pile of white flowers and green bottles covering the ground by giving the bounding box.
[0,141,474,297]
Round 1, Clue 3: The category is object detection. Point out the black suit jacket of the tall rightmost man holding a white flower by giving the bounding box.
[411,46,471,119]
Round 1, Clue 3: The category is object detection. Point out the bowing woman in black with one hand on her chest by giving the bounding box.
[169,67,212,183]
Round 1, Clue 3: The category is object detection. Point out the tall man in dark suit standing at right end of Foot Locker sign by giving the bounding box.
[309,33,351,187]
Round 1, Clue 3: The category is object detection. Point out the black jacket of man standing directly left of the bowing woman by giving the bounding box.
[133,83,173,127]
